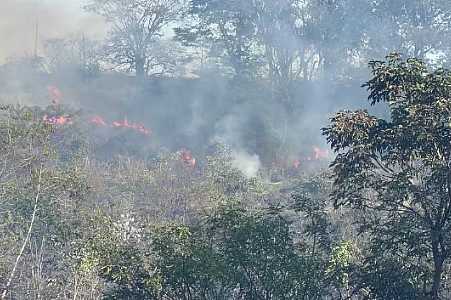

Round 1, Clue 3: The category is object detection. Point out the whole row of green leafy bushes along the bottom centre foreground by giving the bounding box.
[80,199,347,299]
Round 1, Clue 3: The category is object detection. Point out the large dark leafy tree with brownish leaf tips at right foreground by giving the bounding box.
[323,54,451,299]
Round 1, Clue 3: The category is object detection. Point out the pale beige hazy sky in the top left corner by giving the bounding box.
[0,0,105,62]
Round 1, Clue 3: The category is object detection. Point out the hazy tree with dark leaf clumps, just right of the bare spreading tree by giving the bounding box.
[176,0,262,77]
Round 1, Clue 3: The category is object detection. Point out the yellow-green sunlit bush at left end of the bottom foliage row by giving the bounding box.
[78,213,151,299]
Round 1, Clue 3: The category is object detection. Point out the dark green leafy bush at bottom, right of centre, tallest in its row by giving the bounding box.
[207,204,322,299]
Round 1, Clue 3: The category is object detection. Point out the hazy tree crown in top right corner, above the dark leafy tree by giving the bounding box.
[367,0,451,60]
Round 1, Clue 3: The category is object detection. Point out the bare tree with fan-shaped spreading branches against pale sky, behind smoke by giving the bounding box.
[86,0,184,78]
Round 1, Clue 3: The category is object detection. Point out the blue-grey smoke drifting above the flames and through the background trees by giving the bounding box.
[0,0,428,166]
